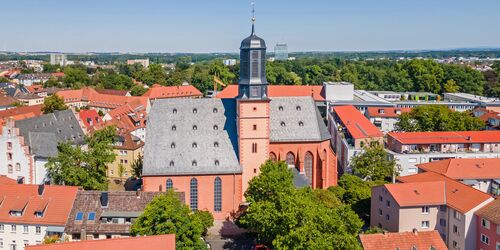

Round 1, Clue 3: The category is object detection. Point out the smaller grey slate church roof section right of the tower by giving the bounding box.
[269,97,331,142]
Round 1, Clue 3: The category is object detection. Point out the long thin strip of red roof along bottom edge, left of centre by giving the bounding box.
[25,234,175,250]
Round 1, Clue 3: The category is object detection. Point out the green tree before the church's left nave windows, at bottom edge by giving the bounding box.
[131,191,213,249]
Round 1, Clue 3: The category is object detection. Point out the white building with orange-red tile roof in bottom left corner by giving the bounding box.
[0,182,78,250]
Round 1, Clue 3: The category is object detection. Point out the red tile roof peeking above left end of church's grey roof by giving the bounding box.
[142,85,203,99]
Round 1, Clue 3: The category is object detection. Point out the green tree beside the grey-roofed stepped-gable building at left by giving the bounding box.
[47,126,116,190]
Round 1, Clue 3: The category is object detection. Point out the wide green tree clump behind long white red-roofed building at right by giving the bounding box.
[396,105,485,132]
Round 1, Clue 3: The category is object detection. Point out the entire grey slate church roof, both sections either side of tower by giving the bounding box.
[143,97,330,176]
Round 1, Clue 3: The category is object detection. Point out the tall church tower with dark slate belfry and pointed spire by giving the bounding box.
[237,5,270,196]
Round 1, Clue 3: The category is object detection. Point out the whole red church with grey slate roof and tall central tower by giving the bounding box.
[143,18,337,220]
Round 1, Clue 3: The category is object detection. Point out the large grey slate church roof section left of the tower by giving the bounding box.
[143,98,241,175]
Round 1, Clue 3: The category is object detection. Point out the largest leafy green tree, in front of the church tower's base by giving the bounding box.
[237,161,363,249]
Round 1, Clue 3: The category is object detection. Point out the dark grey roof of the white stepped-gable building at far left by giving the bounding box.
[15,110,84,157]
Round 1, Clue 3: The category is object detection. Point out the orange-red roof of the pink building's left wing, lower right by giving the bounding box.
[384,181,446,207]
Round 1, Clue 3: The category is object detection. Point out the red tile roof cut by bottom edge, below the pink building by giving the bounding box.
[359,231,448,250]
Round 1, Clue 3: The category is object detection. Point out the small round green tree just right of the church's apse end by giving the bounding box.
[351,143,397,181]
